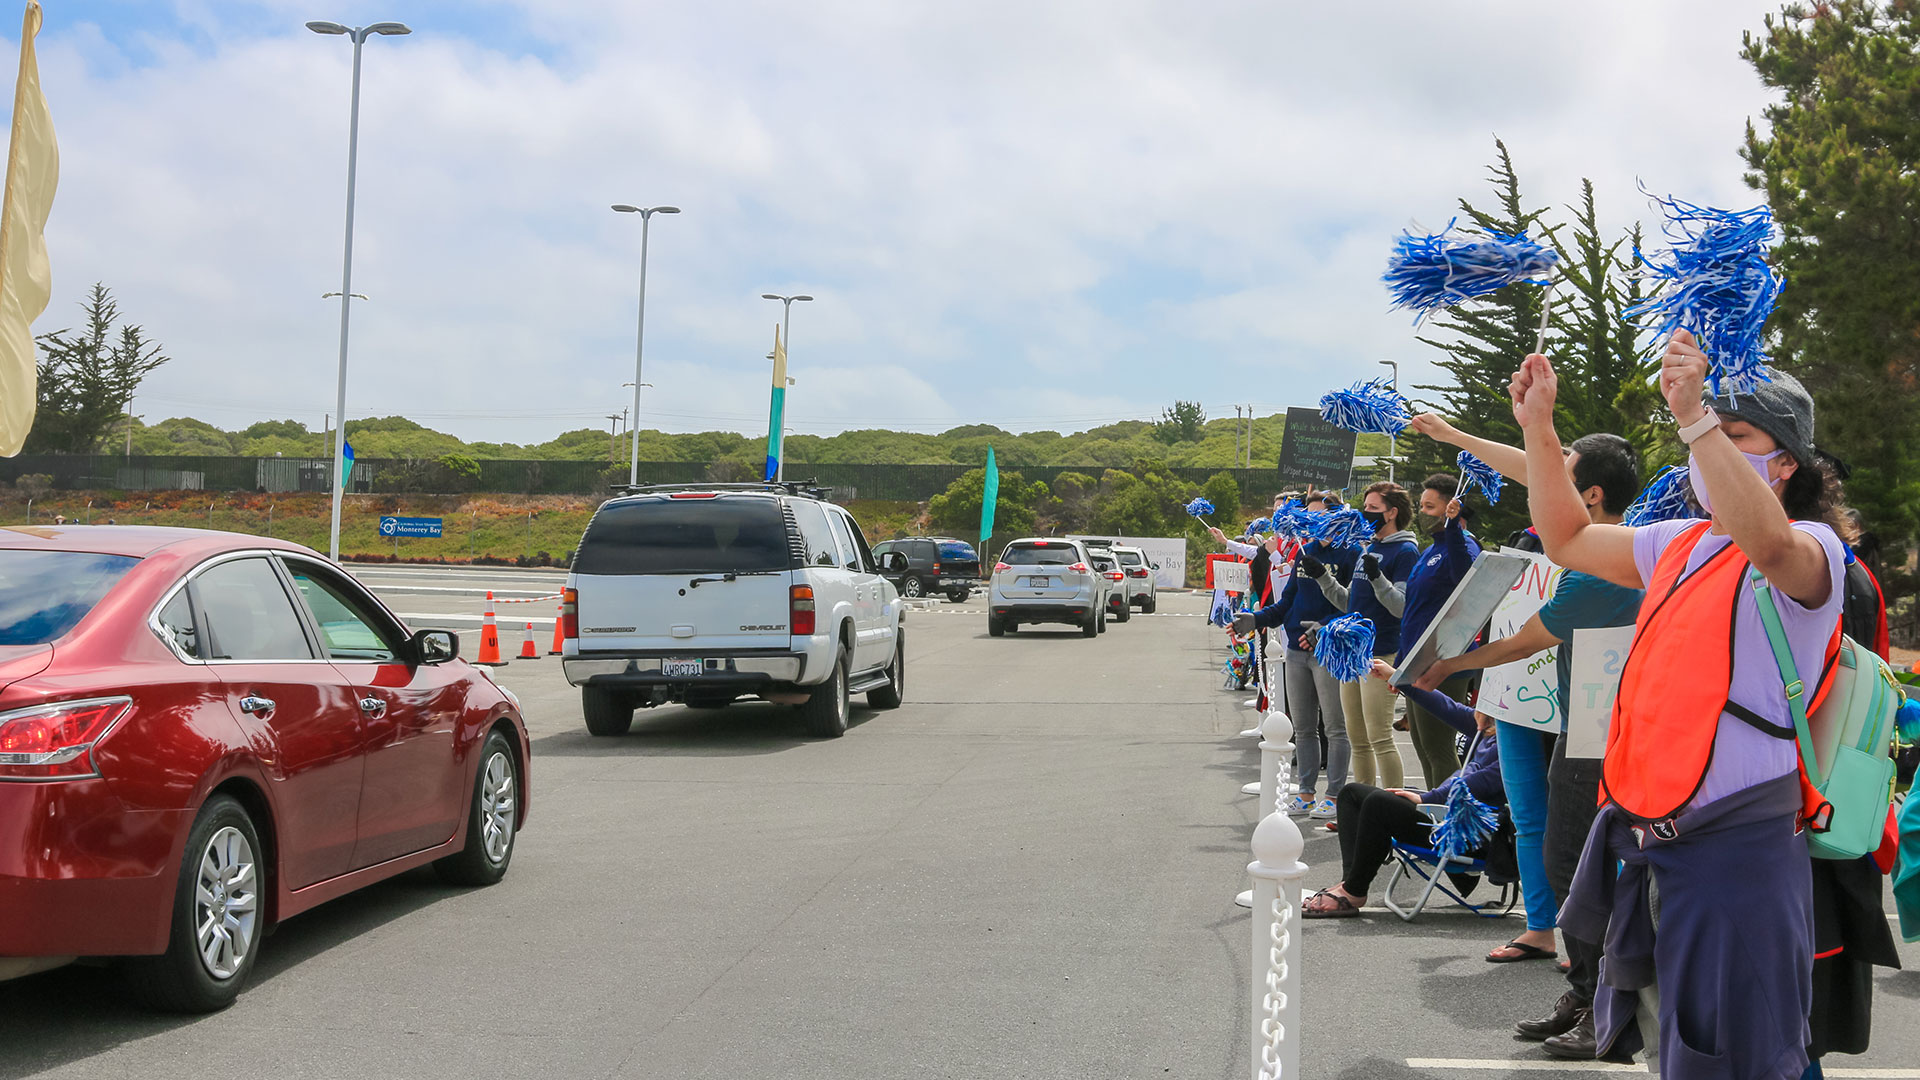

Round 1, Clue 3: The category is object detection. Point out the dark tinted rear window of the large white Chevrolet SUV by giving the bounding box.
[574,496,789,575]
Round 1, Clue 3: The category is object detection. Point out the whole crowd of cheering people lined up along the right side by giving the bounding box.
[1213,332,1899,1080]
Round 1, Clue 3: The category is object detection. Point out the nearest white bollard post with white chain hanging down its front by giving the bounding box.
[1246,813,1308,1080]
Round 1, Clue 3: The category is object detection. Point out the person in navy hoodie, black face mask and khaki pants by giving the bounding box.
[1300,480,1419,788]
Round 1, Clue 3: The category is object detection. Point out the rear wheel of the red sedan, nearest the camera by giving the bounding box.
[127,796,267,1013]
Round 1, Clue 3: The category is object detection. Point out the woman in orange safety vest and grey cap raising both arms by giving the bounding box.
[1509,331,1851,1080]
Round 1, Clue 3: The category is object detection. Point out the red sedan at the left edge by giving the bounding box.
[0,527,528,1011]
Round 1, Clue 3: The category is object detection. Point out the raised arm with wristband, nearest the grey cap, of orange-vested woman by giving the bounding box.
[1661,331,1834,607]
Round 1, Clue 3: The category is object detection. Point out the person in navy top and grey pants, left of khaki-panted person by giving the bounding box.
[1236,496,1354,821]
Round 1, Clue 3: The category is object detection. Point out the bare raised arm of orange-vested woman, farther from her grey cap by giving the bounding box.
[1507,354,1643,588]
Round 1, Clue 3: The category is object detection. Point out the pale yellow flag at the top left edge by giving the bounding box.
[0,0,60,457]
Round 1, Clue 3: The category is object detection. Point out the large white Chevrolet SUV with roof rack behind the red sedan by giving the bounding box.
[561,484,906,738]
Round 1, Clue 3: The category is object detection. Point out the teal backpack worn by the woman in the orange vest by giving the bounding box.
[1747,567,1905,859]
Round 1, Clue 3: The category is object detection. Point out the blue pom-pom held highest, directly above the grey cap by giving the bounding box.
[1622,198,1784,398]
